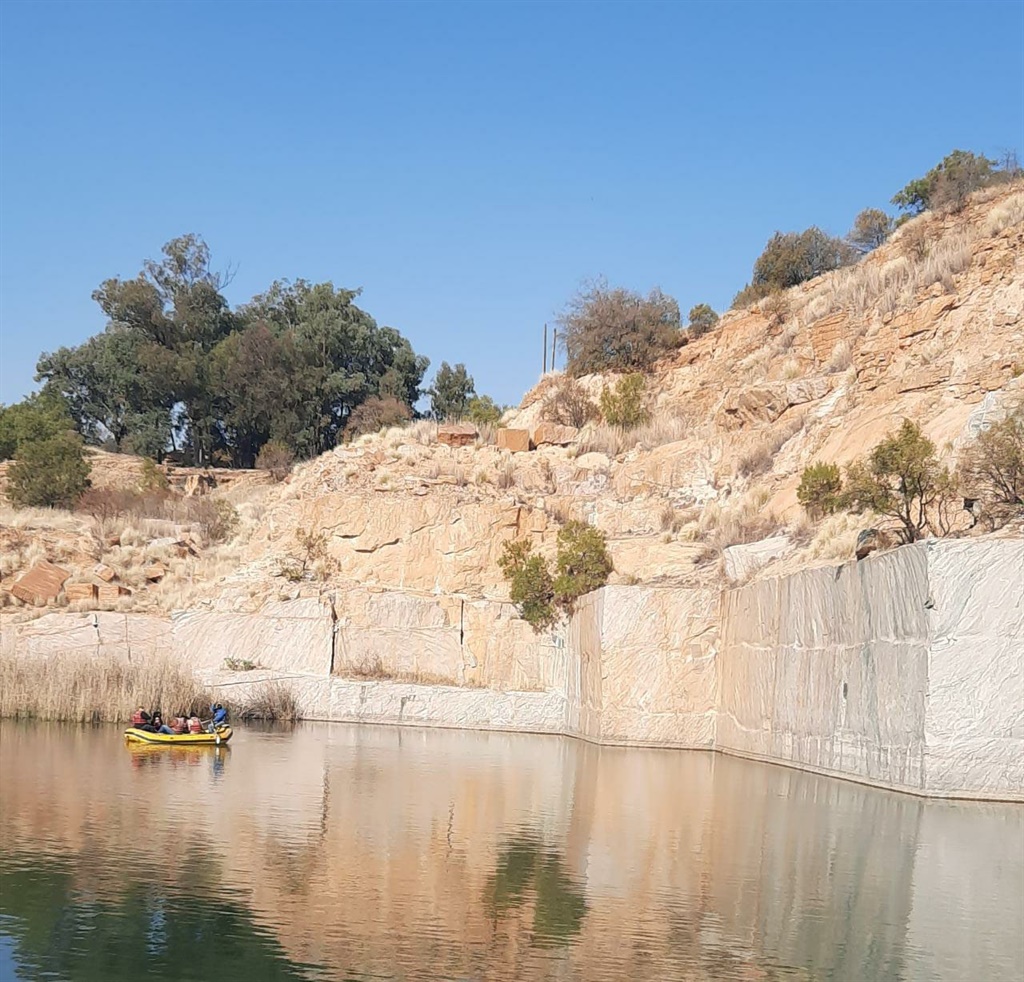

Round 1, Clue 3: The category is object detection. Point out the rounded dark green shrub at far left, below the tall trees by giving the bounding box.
[7,433,91,508]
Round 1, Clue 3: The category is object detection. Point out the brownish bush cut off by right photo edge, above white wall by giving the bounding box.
[958,405,1024,528]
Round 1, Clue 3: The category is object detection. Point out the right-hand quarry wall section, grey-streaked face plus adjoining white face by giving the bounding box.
[716,540,1024,799]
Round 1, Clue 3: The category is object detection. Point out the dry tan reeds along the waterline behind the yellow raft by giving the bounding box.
[0,654,298,723]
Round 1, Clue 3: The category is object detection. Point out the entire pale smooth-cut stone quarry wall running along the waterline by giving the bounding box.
[2,540,1024,799]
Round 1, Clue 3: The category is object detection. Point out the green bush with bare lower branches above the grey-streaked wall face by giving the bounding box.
[840,420,956,542]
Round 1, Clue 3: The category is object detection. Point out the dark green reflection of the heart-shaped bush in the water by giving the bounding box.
[484,834,587,947]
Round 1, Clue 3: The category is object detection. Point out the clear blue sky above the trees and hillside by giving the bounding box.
[0,0,1024,402]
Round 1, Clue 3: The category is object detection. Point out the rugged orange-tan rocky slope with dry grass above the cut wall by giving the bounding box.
[0,188,1024,630]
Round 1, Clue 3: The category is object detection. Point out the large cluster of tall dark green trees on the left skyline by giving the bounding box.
[37,234,429,467]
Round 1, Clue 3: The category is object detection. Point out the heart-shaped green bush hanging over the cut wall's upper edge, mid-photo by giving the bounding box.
[498,521,614,631]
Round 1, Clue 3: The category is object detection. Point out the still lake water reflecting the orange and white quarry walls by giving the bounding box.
[0,723,1024,982]
